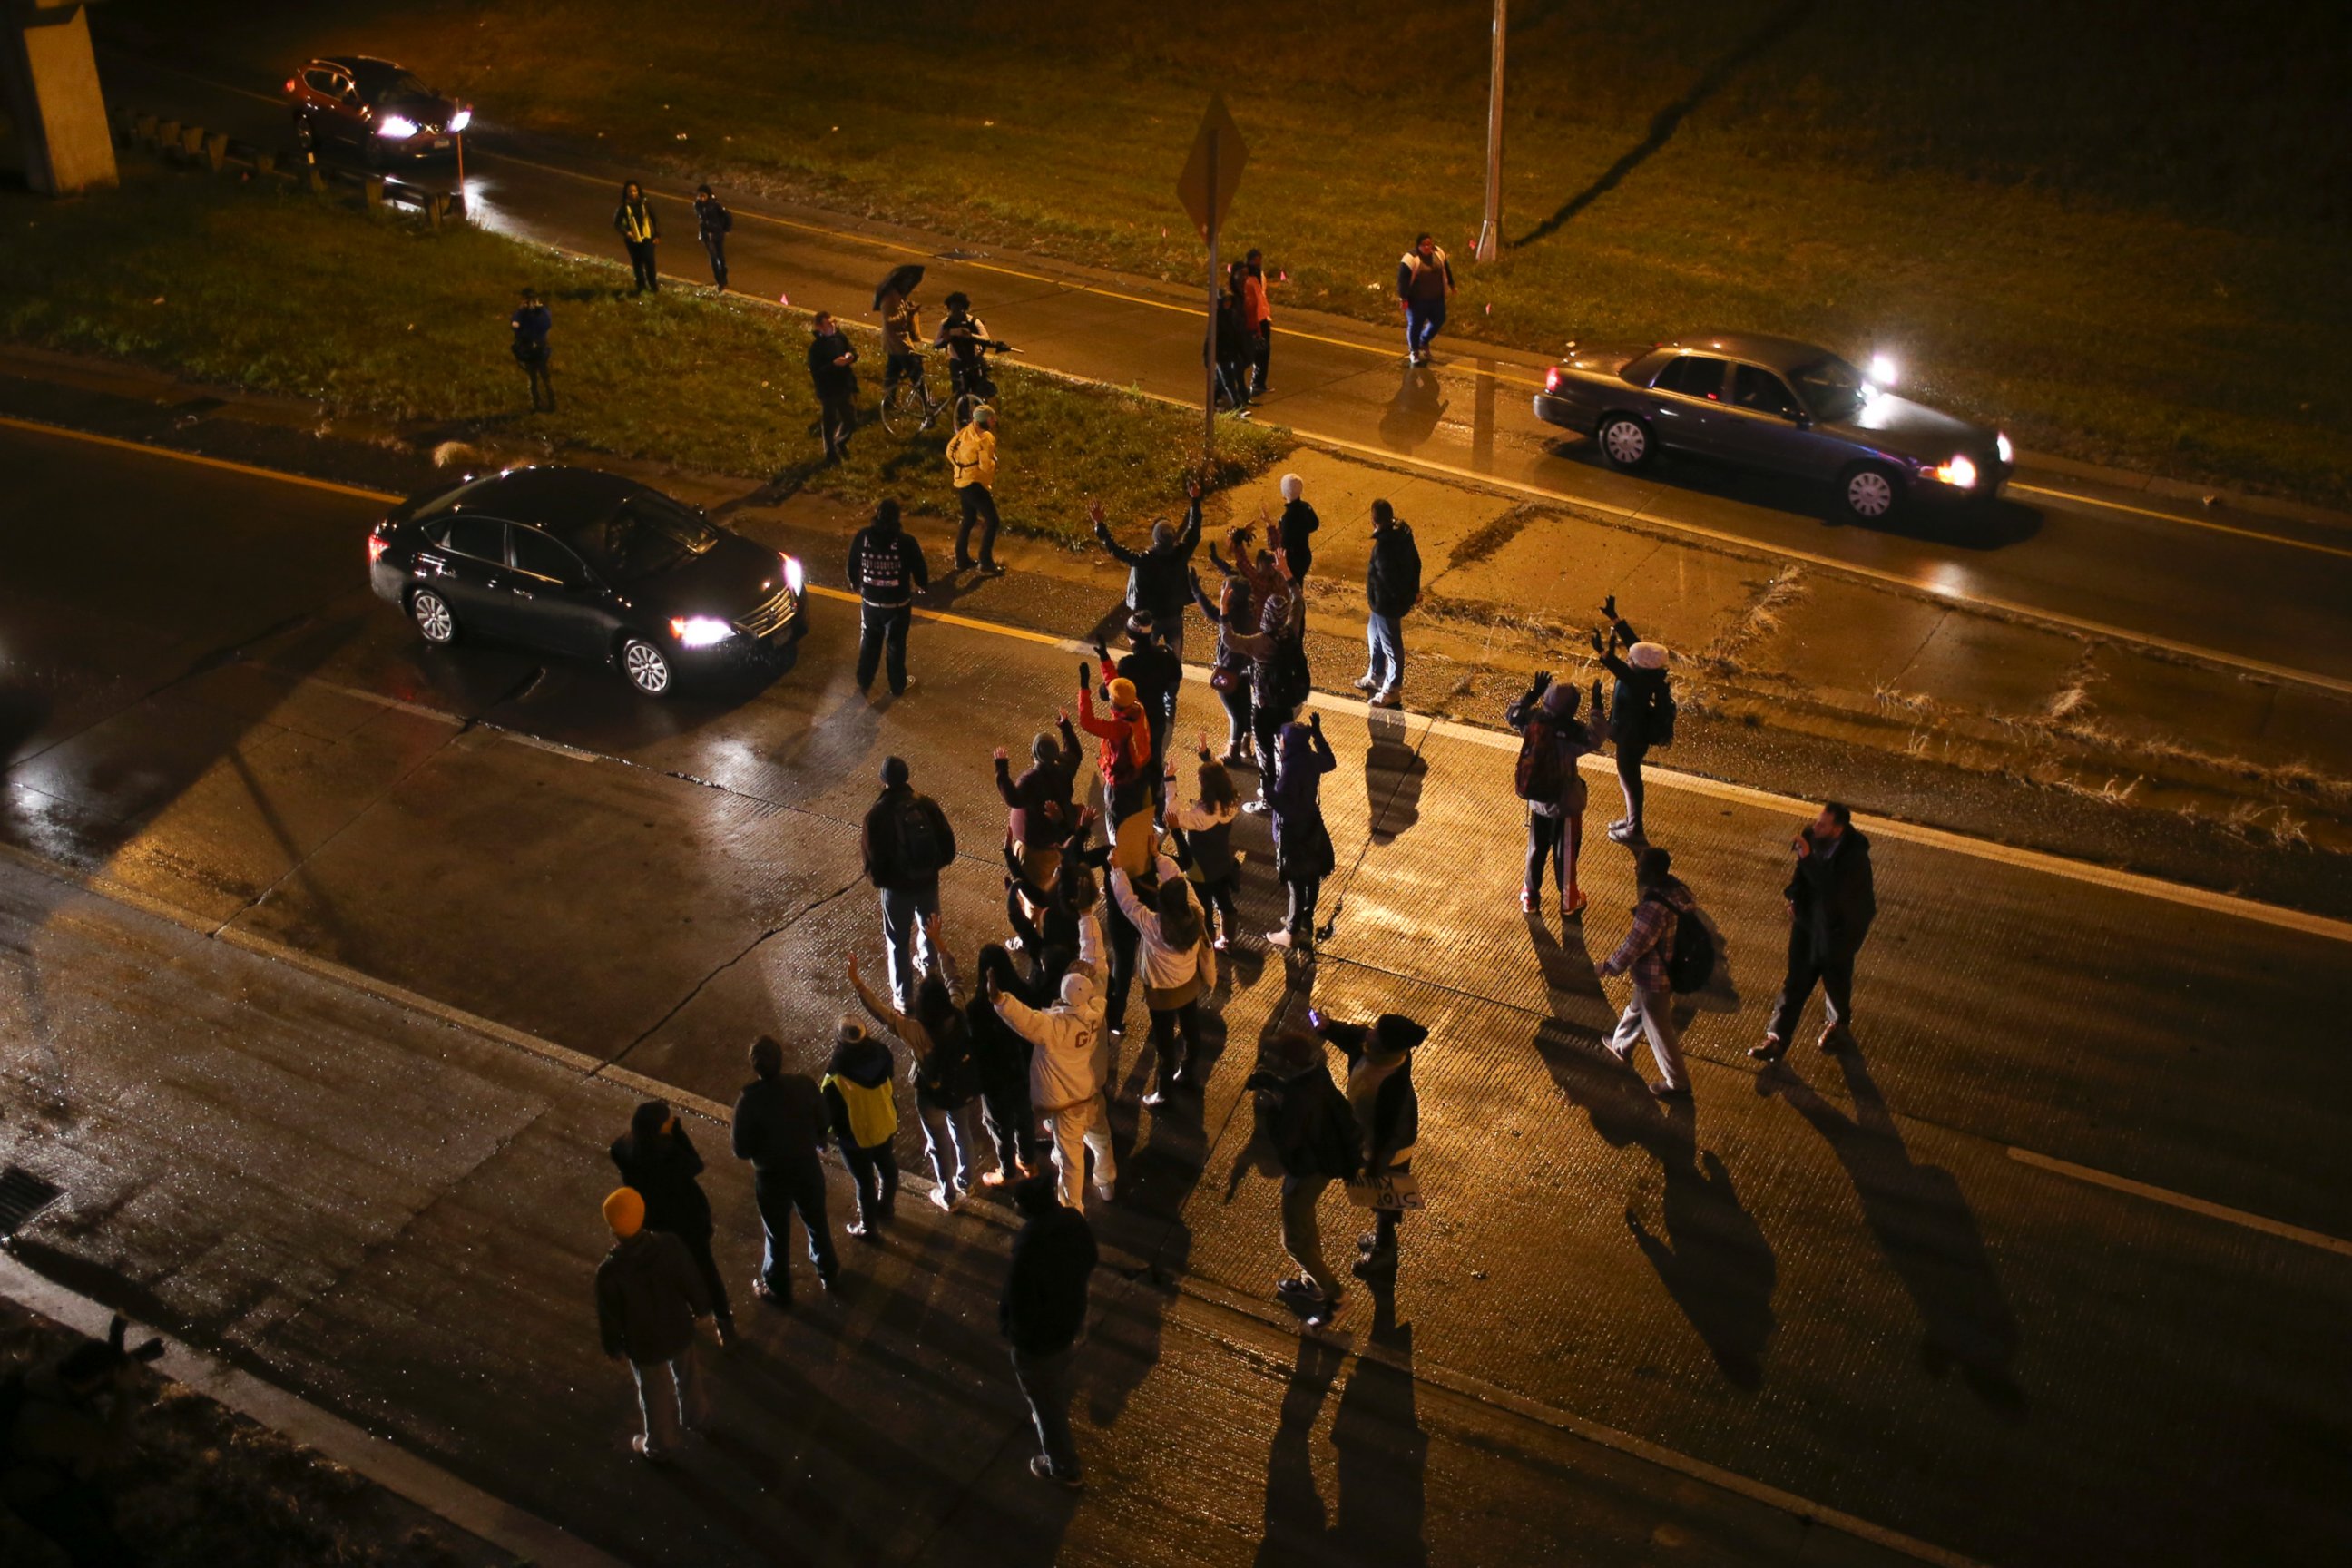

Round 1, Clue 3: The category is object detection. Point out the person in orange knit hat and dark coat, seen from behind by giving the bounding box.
[595,1187,710,1465]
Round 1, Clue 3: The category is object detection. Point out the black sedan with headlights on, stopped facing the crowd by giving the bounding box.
[367,466,809,696]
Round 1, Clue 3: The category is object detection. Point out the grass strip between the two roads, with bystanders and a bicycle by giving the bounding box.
[0,172,1289,541]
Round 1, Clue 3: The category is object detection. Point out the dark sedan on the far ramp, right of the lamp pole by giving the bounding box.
[1536,331,2014,522]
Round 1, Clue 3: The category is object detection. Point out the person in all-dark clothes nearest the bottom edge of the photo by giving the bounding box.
[997,1175,1096,1491]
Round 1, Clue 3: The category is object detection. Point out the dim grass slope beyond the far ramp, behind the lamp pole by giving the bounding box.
[101,0,2352,501]
